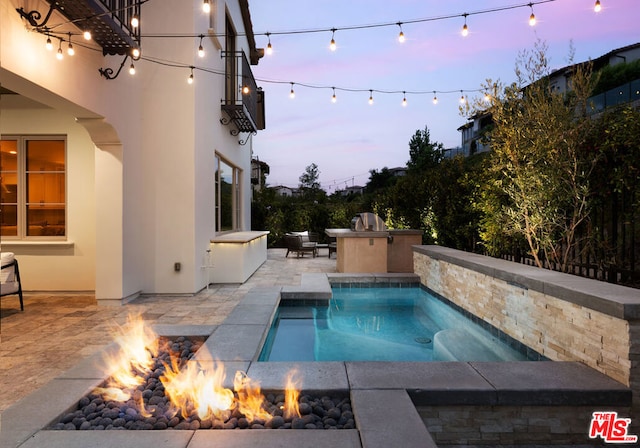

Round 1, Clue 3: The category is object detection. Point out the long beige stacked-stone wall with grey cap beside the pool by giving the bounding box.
[414,246,640,409]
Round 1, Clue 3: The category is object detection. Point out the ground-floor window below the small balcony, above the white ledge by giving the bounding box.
[215,155,240,232]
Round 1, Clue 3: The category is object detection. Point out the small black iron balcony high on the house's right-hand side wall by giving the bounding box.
[220,51,265,135]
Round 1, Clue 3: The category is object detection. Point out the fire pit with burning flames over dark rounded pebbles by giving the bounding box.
[50,320,355,430]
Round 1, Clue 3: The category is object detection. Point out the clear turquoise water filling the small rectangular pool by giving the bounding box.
[259,286,528,361]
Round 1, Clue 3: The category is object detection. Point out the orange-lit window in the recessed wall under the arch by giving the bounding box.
[0,136,67,239]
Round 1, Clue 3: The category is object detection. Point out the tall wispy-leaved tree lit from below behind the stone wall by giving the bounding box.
[473,42,596,271]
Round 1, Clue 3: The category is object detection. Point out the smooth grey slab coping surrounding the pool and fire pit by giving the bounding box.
[0,274,631,448]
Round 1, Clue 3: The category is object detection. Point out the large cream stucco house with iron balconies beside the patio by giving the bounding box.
[0,0,266,304]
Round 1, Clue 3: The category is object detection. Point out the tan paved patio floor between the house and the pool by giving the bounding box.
[0,249,336,413]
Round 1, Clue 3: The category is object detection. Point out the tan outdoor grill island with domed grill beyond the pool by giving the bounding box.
[325,213,422,273]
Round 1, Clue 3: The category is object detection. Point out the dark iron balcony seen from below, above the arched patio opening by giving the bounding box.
[42,0,140,55]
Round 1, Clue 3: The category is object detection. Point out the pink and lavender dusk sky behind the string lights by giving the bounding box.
[249,0,640,193]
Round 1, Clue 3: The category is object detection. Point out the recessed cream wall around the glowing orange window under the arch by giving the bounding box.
[0,108,96,291]
